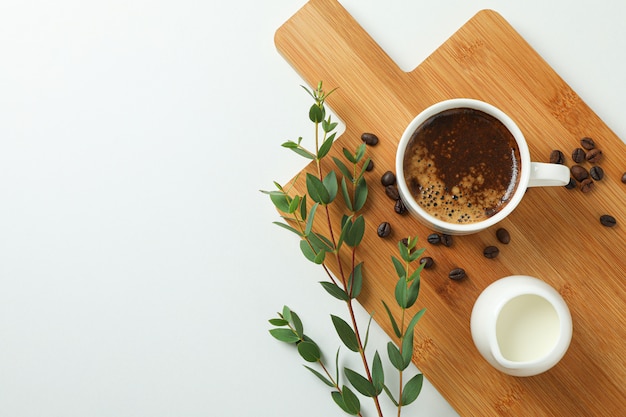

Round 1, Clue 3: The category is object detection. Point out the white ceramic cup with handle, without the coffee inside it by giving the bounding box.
[396,98,570,235]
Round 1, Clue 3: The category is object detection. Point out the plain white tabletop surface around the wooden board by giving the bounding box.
[0,0,626,417]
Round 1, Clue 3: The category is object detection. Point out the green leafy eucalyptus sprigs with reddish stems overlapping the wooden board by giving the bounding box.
[263,82,423,417]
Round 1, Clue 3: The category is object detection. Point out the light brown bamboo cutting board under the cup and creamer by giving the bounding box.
[275,0,626,416]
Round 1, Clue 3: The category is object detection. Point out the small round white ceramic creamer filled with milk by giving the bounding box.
[470,275,572,376]
